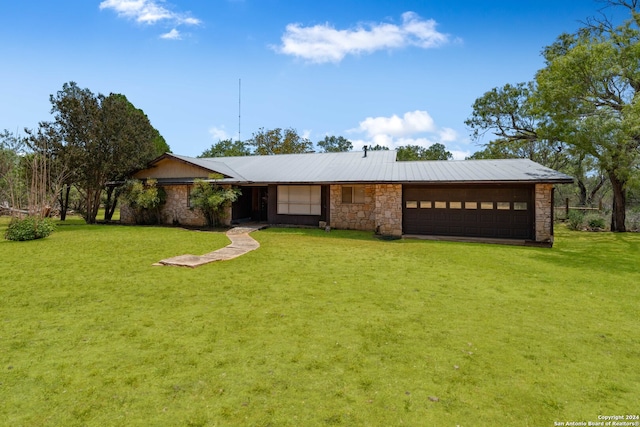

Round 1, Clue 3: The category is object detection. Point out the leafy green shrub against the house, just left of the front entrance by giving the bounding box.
[191,174,240,227]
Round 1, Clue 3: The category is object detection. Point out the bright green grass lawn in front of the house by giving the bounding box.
[0,219,640,427]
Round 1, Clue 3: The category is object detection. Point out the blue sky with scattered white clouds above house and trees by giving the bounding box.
[0,0,632,159]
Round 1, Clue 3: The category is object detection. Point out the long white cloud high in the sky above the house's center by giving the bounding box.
[275,12,449,63]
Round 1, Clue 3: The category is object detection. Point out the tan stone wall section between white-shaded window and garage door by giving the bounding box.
[329,184,402,236]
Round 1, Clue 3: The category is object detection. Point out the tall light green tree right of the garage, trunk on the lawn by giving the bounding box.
[535,1,640,232]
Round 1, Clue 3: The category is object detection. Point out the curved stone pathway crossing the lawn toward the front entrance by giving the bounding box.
[154,224,266,268]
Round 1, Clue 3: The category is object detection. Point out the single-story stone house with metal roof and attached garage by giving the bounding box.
[121,149,573,246]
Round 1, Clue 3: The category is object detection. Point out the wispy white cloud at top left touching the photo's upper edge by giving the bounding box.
[100,0,202,25]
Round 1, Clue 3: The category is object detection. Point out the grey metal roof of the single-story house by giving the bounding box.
[156,150,573,184]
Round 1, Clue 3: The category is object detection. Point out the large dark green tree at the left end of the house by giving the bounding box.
[46,82,169,223]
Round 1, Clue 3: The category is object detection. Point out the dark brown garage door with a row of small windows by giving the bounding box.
[402,185,534,239]
